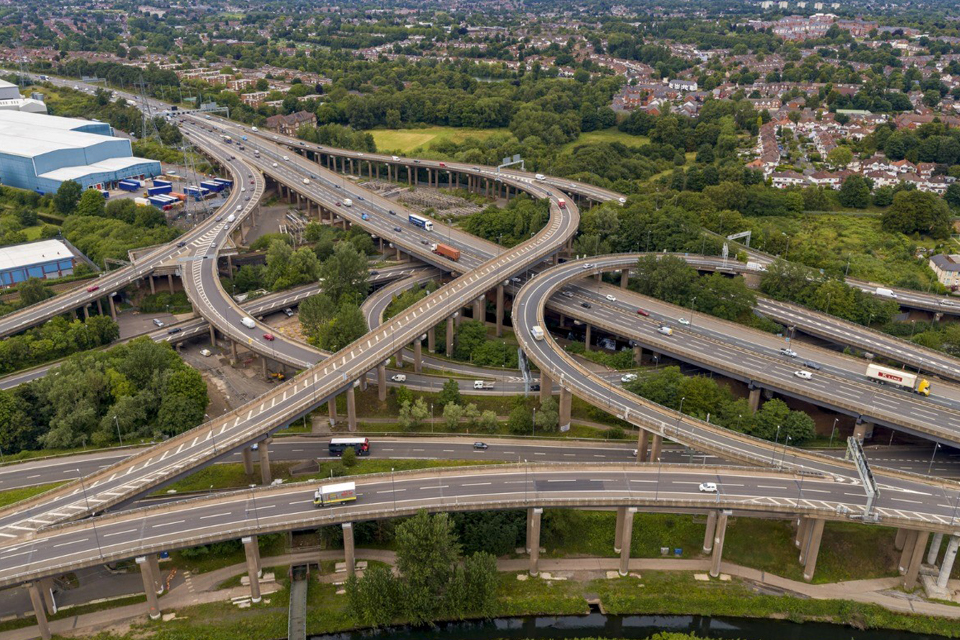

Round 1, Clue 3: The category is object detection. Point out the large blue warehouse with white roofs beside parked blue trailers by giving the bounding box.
[0,110,161,193]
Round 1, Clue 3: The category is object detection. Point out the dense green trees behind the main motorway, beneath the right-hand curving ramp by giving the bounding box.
[630,256,757,320]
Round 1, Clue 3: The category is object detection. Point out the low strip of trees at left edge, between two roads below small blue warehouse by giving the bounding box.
[0,316,120,374]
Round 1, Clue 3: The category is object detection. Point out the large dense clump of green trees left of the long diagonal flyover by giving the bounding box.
[0,338,207,452]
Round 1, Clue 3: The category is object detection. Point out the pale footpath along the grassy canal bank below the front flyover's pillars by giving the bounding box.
[0,549,960,640]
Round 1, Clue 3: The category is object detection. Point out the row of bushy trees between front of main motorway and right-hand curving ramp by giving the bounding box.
[627,367,816,445]
